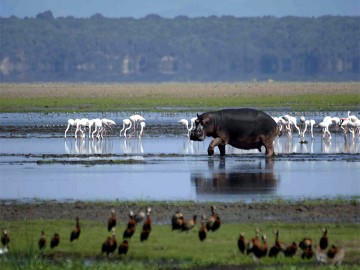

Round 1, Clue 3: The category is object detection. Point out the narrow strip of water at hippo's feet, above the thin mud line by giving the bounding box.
[0,134,360,155]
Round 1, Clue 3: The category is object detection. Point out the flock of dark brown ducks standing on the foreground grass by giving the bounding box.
[0,206,345,265]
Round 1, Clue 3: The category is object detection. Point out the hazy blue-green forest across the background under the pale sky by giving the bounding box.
[0,11,360,82]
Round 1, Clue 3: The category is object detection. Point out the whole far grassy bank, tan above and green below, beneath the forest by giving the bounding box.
[0,82,360,112]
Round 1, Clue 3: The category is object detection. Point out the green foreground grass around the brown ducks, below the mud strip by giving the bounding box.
[0,220,360,269]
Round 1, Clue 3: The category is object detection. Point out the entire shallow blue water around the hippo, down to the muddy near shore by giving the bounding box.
[0,110,360,202]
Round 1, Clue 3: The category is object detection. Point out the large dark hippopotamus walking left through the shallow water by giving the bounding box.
[190,108,279,157]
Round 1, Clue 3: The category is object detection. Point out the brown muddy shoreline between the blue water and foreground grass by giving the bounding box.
[0,199,360,225]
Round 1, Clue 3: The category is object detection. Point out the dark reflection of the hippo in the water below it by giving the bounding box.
[191,159,277,194]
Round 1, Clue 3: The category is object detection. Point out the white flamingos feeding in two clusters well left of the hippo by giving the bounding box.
[64,114,145,140]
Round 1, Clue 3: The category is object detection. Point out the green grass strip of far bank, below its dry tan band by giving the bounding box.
[0,94,360,112]
